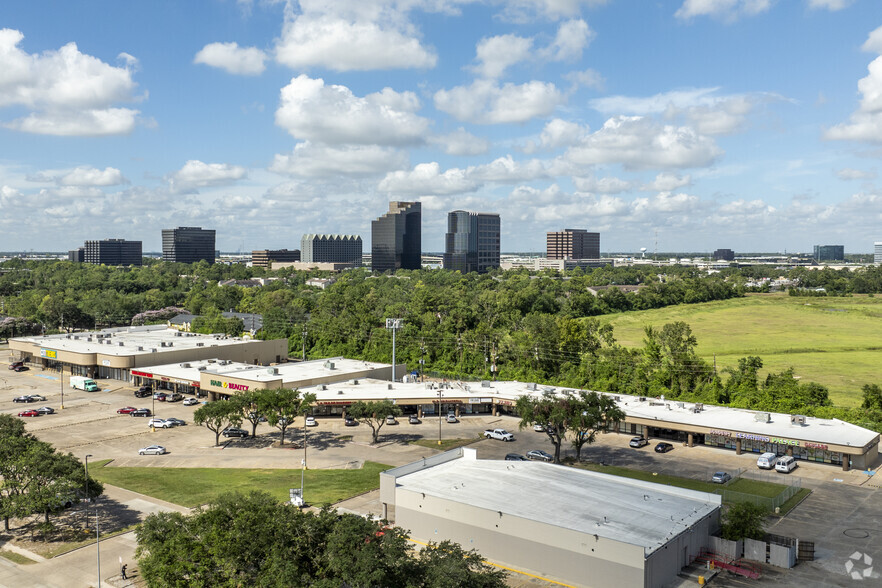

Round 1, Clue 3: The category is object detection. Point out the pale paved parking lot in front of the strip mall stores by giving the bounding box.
[0,364,882,587]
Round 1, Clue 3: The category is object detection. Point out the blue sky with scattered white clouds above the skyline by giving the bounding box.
[0,0,882,253]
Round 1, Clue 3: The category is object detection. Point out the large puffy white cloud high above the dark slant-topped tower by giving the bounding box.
[276,75,429,145]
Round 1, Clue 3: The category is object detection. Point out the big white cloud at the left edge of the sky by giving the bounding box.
[0,29,139,136]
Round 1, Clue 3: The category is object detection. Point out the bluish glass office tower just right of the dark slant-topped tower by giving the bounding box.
[443,210,500,274]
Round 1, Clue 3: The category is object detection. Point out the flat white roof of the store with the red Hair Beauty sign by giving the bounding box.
[138,357,392,385]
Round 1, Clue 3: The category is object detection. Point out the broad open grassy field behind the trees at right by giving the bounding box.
[599,294,882,406]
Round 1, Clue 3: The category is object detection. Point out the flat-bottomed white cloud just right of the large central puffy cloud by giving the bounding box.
[435,80,565,124]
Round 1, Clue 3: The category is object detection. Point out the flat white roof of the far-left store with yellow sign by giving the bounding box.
[13,325,260,356]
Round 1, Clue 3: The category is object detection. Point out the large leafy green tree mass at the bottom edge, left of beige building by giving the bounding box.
[135,491,505,588]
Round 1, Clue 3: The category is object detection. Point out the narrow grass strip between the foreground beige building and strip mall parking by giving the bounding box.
[576,463,811,516]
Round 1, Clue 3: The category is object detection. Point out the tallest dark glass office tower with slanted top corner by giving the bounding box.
[371,202,422,272]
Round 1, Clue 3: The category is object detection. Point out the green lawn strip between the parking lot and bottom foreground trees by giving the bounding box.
[89,460,391,507]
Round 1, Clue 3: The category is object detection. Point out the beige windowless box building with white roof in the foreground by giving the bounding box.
[380,448,722,588]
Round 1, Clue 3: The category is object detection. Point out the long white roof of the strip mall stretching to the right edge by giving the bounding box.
[305,379,879,447]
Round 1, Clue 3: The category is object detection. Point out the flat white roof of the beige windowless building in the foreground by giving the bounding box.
[396,453,722,556]
